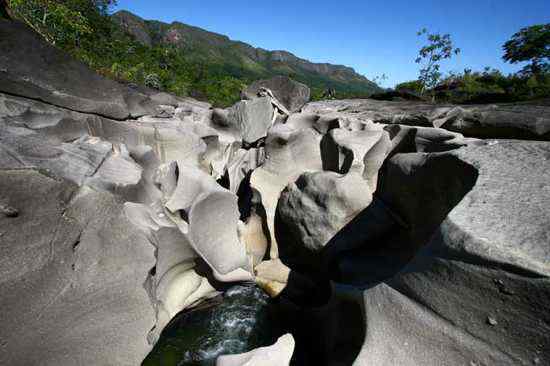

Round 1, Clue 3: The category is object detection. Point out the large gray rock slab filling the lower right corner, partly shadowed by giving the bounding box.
[355,141,550,365]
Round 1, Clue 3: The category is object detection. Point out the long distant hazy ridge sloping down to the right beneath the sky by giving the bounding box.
[112,10,381,97]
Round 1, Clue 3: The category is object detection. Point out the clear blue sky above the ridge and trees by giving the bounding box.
[117,0,550,87]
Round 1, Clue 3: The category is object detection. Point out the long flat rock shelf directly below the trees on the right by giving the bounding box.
[302,99,550,141]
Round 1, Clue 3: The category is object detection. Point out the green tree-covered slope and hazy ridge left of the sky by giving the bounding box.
[7,0,379,106]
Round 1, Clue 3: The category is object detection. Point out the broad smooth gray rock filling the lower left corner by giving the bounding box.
[0,169,155,366]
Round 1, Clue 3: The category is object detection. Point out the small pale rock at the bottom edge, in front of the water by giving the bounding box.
[216,334,294,366]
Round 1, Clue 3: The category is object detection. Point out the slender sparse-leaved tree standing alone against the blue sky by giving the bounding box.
[415,28,460,94]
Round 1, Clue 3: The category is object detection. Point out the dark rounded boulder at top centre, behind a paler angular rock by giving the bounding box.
[242,76,311,112]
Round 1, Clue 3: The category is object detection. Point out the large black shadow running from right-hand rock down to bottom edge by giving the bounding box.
[275,148,478,366]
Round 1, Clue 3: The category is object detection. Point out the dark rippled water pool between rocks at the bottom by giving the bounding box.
[143,285,277,366]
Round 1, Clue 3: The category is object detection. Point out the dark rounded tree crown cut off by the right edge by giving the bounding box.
[502,23,550,75]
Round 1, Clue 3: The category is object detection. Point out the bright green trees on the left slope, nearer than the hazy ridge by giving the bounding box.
[8,0,248,106]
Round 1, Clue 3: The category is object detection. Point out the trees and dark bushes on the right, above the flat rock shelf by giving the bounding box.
[402,24,550,103]
